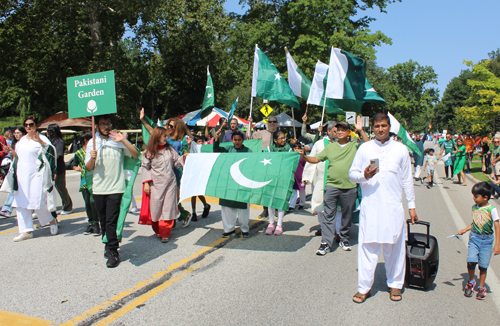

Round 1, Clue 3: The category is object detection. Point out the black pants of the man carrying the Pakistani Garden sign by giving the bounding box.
[94,194,123,251]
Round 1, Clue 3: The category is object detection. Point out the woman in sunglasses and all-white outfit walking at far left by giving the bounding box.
[8,116,58,241]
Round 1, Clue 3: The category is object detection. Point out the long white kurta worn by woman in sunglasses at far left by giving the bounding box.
[12,135,51,209]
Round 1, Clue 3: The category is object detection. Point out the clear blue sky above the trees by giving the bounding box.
[225,0,500,95]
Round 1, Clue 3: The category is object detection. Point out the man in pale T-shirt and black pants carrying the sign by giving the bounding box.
[85,114,139,268]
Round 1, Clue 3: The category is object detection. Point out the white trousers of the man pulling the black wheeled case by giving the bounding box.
[358,233,406,294]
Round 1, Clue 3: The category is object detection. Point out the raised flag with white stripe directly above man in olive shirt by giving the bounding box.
[325,47,366,112]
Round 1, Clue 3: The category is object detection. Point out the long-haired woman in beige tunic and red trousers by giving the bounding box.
[141,127,184,242]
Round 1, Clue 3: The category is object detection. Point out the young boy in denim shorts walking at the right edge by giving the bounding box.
[458,182,500,300]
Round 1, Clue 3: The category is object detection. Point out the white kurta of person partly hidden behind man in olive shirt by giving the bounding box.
[302,139,326,212]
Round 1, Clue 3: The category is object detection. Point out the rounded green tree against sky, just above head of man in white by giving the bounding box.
[384,60,439,131]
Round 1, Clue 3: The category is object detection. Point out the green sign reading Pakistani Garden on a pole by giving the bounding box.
[66,70,116,119]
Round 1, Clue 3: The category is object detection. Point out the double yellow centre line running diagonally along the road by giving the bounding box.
[60,220,261,326]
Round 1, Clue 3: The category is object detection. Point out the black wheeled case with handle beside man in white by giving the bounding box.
[406,220,439,290]
